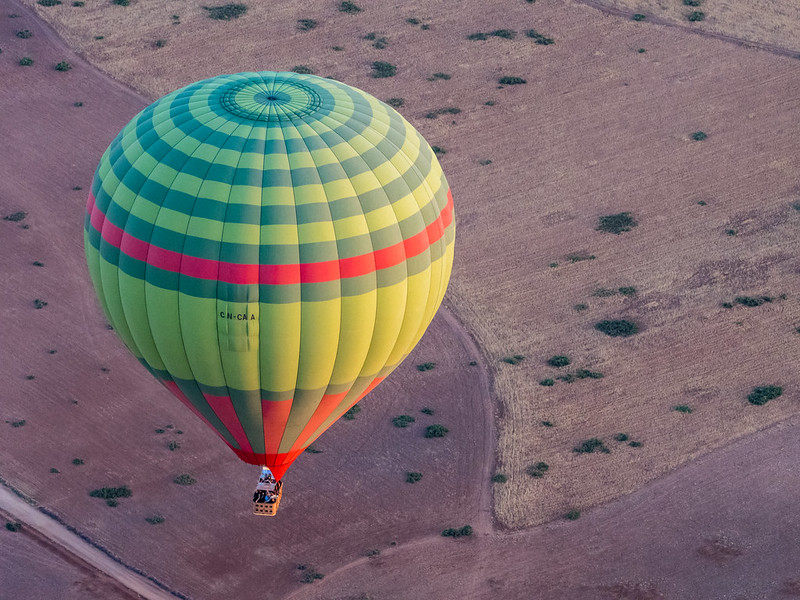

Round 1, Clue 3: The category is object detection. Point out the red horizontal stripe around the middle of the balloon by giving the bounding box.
[87,190,453,285]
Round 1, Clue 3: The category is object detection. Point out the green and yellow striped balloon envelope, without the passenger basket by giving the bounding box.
[84,72,455,513]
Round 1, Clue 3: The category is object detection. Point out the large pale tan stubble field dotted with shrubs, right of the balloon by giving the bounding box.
[3,0,800,568]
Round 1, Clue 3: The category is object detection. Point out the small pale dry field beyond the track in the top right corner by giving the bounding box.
[587,0,800,51]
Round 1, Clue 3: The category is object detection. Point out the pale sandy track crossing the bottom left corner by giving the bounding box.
[0,486,170,600]
